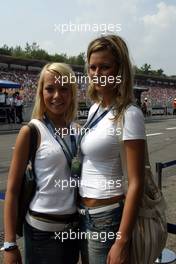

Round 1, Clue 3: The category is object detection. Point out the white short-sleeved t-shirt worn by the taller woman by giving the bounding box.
[79,104,146,199]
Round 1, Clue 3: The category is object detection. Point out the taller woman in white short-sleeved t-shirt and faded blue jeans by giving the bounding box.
[79,35,146,264]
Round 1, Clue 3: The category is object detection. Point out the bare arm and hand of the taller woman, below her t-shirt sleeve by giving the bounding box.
[107,139,145,264]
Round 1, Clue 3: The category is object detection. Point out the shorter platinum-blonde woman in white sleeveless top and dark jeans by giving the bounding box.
[4,63,78,264]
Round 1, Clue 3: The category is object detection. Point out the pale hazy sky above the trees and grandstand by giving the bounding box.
[0,0,176,75]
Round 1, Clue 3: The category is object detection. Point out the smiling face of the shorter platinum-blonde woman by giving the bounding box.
[43,71,72,118]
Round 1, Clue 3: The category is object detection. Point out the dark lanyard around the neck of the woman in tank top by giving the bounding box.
[43,114,77,167]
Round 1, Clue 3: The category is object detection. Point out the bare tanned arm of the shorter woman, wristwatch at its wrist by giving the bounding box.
[4,126,30,264]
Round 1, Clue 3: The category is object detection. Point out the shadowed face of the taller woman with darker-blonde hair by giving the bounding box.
[88,50,118,94]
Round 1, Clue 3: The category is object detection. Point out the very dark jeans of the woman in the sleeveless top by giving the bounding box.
[24,222,79,264]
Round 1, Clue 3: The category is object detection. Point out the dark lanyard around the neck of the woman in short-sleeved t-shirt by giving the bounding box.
[78,104,113,146]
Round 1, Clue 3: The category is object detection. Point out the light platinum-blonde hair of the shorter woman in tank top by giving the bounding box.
[32,62,77,123]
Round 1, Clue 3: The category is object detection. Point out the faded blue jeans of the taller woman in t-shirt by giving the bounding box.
[80,202,123,264]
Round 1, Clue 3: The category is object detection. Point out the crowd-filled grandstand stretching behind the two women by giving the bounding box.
[0,55,176,112]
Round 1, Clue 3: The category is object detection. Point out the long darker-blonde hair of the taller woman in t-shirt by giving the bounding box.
[87,35,134,120]
